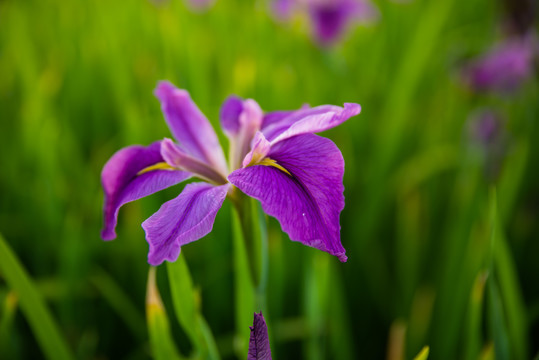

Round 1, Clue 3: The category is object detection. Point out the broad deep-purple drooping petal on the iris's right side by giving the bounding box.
[228,134,347,262]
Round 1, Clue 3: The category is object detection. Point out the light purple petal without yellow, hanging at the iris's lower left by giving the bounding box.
[142,183,230,266]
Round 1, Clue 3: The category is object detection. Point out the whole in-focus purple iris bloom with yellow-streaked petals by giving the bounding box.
[101,82,361,265]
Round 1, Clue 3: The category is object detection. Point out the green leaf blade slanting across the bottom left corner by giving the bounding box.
[0,234,73,360]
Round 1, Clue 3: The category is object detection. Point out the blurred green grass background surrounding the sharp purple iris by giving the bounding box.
[0,0,539,360]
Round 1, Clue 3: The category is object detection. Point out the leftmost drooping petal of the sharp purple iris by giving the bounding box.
[101,141,191,240]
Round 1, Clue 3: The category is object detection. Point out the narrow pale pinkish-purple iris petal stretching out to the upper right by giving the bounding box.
[262,103,361,144]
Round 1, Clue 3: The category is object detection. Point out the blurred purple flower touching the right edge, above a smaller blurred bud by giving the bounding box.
[463,34,538,93]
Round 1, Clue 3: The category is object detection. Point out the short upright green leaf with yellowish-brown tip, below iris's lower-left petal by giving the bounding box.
[146,267,182,360]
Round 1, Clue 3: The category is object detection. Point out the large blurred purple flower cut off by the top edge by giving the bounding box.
[273,0,379,46]
